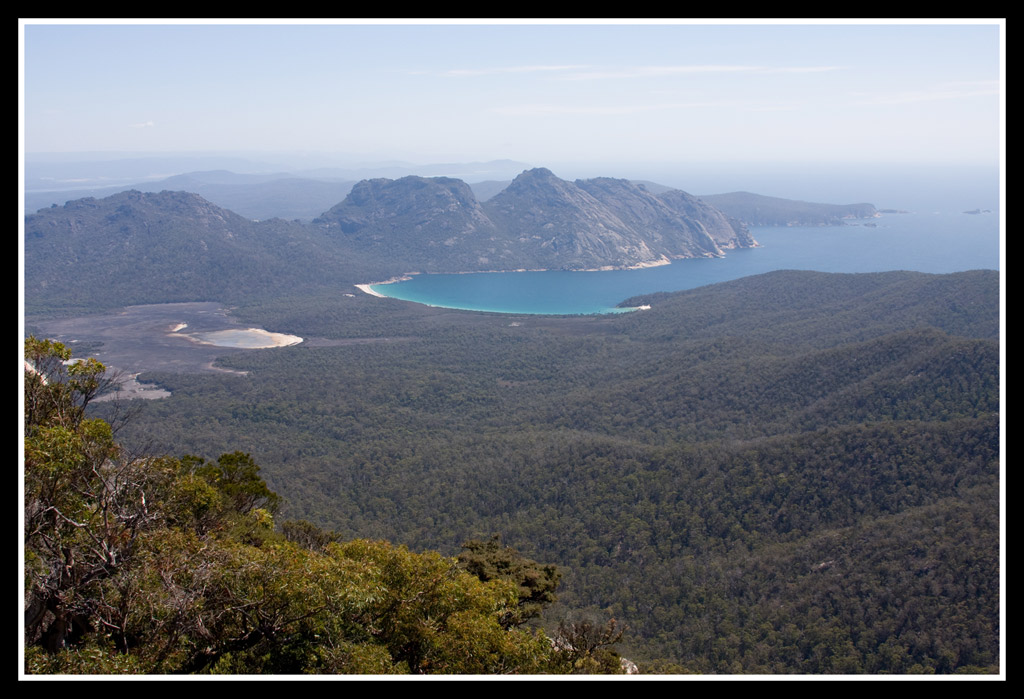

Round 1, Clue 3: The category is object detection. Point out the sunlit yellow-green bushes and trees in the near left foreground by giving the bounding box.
[24,337,621,674]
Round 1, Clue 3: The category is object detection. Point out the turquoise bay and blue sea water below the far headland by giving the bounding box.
[373,212,999,314]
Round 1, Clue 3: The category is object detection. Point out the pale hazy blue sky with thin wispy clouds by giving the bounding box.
[23,19,1000,164]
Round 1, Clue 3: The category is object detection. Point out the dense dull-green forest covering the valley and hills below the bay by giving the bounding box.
[66,271,1000,673]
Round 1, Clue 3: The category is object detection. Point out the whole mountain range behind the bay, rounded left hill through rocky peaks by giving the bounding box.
[25,168,873,312]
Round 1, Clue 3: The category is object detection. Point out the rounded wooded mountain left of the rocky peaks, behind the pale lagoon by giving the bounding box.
[25,190,380,312]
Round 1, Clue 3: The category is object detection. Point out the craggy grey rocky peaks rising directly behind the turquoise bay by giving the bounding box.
[313,168,757,271]
